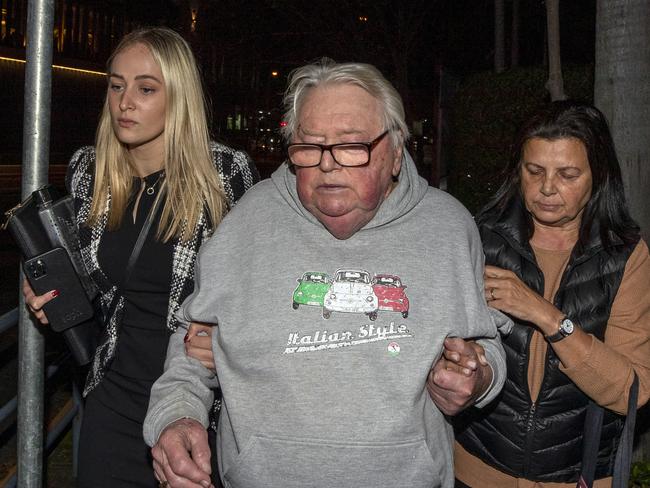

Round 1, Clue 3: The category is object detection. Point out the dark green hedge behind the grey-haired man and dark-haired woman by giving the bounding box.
[448,66,593,213]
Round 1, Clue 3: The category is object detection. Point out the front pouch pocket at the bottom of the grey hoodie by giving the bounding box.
[224,436,440,488]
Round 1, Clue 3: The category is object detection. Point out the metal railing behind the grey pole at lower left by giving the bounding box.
[0,308,83,488]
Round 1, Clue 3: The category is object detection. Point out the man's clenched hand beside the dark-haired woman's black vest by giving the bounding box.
[427,338,492,415]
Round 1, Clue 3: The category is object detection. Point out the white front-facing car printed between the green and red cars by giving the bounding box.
[323,269,378,320]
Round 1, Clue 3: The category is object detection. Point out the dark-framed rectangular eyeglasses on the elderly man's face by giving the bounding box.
[287,131,388,168]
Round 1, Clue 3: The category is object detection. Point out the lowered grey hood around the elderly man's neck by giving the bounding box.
[271,149,429,237]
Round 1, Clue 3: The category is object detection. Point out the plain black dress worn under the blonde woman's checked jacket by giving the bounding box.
[78,171,173,488]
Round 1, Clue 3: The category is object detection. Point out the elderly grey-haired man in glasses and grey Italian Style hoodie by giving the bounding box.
[144,60,505,488]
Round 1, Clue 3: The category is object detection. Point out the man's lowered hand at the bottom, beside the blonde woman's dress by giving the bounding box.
[151,419,213,488]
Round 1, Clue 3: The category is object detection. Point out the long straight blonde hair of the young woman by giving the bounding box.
[87,27,227,241]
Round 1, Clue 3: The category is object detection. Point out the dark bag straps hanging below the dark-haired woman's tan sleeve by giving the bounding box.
[576,373,639,488]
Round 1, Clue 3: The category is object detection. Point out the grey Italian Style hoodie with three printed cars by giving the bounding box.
[144,154,505,488]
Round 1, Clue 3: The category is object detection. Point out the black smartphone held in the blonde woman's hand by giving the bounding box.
[23,247,93,332]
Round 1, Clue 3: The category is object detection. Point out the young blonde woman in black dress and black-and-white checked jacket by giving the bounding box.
[24,28,259,487]
